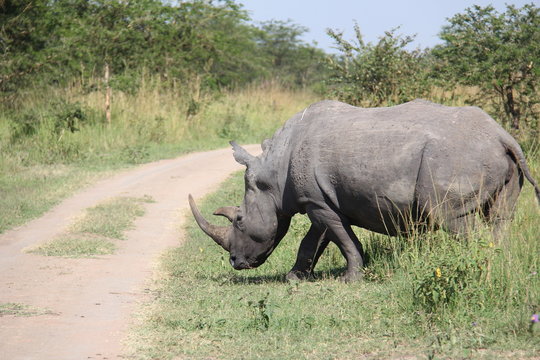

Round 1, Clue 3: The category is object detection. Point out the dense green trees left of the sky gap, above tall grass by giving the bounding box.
[0,0,325,94]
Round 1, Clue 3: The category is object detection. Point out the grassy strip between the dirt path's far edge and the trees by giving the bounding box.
[0,78,317,232]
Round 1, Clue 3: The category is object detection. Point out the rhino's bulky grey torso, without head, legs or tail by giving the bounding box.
[268,100,508,232]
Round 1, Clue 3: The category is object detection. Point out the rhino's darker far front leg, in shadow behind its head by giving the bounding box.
[286,225,330,280]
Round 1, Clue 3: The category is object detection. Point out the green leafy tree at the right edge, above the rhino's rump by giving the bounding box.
[433,4,540,130]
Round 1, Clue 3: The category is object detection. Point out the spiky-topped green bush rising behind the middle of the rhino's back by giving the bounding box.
[328,25,431,107]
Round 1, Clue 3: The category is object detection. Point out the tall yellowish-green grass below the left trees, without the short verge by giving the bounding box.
[0,81,316,166]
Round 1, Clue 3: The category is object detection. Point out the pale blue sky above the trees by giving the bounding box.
[238,0,540,52]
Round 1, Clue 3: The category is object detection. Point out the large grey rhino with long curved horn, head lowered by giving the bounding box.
[189,100,540,281]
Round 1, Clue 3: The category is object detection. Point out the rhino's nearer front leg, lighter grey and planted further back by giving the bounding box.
[308,208,364,282]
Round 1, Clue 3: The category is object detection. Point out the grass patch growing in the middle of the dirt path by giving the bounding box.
[27,196,153,257]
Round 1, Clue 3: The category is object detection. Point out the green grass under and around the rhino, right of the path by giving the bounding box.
[130,159,540,359]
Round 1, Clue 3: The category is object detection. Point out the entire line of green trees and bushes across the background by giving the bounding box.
[0,0,540,134]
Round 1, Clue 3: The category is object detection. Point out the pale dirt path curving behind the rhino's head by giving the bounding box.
[0,146,260,360]
